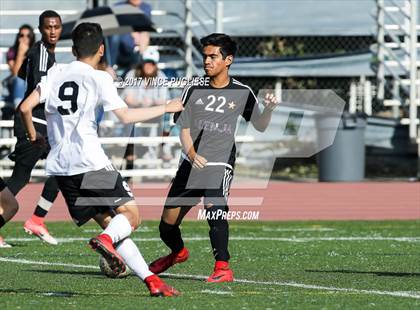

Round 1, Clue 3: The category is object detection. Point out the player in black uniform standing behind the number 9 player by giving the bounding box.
[1,10,62,244]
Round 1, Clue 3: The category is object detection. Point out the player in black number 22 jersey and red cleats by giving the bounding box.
[149,33,277,282]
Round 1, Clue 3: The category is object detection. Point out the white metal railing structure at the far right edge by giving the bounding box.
[376,0,420,140]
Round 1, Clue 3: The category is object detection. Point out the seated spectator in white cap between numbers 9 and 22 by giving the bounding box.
[121,47,172,169]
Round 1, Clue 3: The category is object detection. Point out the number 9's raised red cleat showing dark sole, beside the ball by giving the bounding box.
[89,234,125,274]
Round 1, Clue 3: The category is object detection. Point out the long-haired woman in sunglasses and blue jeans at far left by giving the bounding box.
[3,25,35,114]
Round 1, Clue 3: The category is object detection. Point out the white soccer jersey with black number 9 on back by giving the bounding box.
[38,61,127,176]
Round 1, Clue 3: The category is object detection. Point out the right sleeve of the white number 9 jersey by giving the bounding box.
[98,72,127,112]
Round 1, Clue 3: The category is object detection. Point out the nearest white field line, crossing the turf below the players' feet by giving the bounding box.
[0,257,420,299]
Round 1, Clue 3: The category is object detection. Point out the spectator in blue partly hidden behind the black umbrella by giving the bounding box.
[109,0,152,72]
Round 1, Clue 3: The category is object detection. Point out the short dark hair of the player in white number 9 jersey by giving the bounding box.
[71,23,104,58]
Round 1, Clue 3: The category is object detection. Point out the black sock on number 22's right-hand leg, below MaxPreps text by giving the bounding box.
[206,206,230,262]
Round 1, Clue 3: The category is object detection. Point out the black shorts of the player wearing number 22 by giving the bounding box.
[165,160,233,208]
